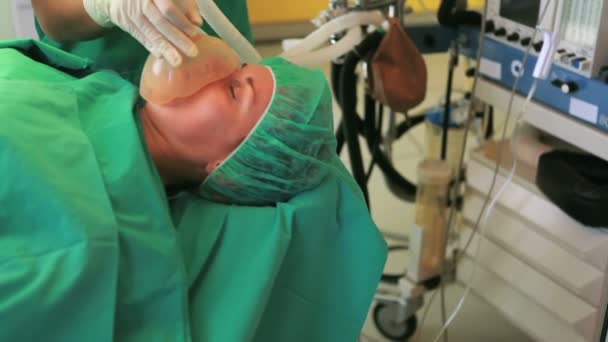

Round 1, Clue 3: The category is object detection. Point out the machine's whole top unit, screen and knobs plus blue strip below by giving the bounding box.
[479,0,608,135]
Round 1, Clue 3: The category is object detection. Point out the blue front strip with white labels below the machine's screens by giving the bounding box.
[480,36,608,132]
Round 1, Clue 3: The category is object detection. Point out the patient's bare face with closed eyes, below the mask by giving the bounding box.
[146,65,274,172]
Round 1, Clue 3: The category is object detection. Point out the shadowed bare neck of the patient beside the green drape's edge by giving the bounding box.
[139,106,196,188]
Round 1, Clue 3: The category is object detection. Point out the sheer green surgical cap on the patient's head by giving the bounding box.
[199,57,336,206]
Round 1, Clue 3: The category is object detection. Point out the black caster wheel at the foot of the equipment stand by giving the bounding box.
[374,303,418,342]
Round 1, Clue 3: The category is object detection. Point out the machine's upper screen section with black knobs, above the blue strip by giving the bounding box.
[486,0,608,80]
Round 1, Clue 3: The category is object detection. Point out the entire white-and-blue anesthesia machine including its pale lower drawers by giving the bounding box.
[470,0,608,342]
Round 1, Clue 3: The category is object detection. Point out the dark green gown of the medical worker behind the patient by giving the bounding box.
[36,0,253,85]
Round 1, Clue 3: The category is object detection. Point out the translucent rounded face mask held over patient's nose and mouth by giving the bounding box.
[140,34,240,105]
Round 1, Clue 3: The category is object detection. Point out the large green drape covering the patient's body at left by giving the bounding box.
[0,41,191,342]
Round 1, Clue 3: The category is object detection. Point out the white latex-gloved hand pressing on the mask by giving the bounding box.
[83,0,203,67]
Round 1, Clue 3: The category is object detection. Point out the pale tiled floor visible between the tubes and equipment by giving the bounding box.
[258,44,532,342]
